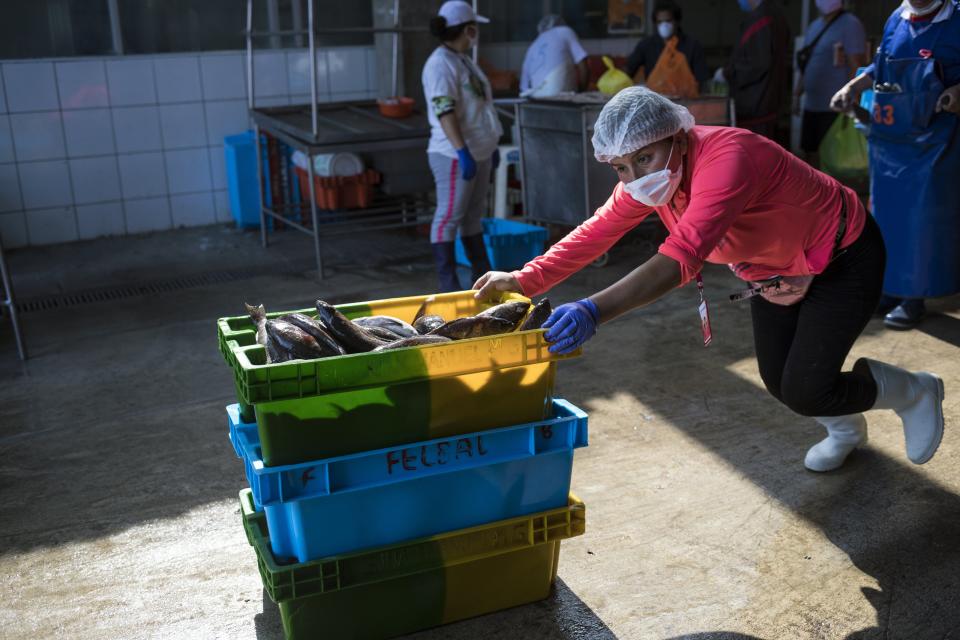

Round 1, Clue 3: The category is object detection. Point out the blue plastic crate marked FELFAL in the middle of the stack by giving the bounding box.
[227,400,587,562]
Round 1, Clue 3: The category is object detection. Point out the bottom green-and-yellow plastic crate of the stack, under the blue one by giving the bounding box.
[240,489,586,640]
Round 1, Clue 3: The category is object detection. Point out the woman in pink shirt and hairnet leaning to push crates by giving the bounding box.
[474,87,943,471]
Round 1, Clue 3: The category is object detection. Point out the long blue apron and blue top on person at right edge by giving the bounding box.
[869,4,960,298]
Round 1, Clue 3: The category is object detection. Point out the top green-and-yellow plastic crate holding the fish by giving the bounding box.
[217,291,579,466]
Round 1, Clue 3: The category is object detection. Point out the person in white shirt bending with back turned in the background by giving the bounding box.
[520,13,588,98]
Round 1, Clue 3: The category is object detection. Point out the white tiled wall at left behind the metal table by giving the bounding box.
[0,47,376,247]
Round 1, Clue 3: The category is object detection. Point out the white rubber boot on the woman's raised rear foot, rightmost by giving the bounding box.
[864,358,944,464]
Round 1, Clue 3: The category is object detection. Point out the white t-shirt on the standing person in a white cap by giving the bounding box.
[422,45,503,160]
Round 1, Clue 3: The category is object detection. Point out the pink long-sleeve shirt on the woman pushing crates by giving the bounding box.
[513,126,866,296]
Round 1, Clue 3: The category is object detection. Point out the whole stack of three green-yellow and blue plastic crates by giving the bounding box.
[218,292,587,638]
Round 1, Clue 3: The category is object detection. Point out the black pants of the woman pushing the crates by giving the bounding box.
[751,215,886,416]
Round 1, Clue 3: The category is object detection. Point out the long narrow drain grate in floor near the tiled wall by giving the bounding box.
[17,267,296,313]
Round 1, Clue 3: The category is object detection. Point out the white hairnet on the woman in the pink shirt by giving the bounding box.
[593,87,696,162]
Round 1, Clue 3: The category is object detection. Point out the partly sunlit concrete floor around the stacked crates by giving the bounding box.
[0,222,960,640]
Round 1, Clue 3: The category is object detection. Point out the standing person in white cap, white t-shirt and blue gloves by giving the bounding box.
[422,0,503,291]
